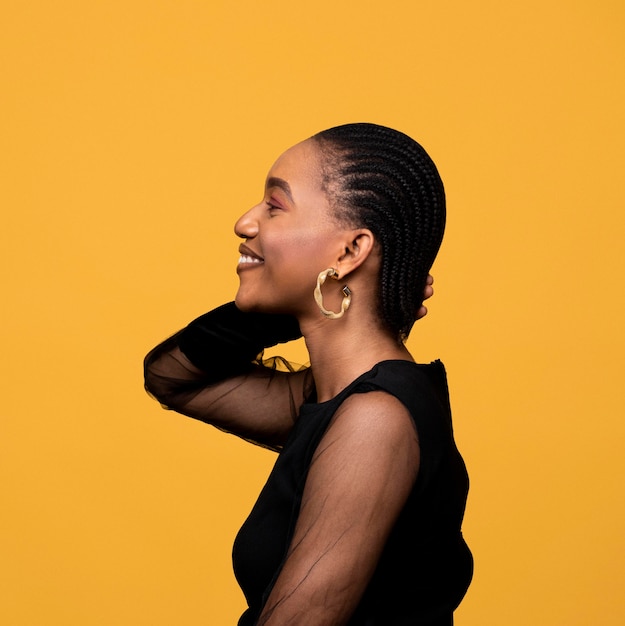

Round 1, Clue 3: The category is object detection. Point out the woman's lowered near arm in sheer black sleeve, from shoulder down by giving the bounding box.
[258,392,419,626]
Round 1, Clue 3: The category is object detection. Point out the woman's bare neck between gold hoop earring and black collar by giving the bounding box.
[300,307,413,402]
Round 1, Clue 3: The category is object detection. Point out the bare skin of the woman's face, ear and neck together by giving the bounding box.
[235,140,412,401]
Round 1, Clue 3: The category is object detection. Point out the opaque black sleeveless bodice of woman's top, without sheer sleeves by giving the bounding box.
[233,360,473,626]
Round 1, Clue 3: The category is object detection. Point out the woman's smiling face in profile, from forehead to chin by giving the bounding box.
[235,140,345,315]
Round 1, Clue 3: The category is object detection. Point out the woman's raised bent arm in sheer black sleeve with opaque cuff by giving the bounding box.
[144,303,312,448]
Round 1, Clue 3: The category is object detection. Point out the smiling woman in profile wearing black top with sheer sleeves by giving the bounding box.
[146,124,472,626]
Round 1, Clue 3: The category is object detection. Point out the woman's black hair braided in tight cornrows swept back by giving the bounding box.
[312,123,445,341]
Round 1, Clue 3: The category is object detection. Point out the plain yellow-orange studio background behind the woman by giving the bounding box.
[0,0,625,626]
